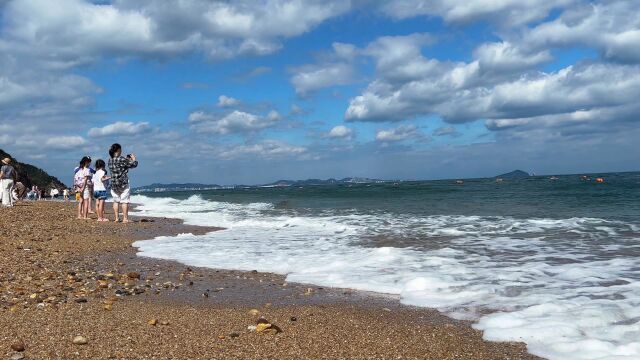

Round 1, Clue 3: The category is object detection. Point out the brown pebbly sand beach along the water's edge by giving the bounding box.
[0,202,535,359]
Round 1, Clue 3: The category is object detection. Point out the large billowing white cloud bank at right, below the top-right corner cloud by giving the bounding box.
[345,27,640,128]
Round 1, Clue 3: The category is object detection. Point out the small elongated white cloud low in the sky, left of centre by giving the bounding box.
[189,110,280,135]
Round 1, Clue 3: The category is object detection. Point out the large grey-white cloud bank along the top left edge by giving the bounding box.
[3,0,350,67]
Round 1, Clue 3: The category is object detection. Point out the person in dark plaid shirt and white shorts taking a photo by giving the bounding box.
[109,143,138,223]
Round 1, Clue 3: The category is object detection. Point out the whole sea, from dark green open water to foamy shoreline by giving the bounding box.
[134,173,640,360]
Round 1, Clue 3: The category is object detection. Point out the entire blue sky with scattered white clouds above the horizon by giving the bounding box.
[0,0,640,186]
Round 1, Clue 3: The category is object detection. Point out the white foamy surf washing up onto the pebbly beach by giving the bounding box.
[134,196,640,359]
